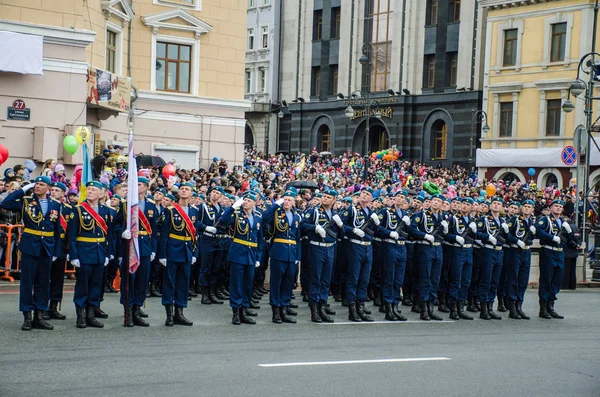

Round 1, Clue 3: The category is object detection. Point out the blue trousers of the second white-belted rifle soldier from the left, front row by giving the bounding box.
[346,242,373,303]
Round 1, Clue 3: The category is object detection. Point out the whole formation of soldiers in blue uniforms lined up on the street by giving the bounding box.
[0,176,579,330]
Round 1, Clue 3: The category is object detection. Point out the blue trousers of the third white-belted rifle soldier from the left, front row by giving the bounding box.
[381,243,406,303]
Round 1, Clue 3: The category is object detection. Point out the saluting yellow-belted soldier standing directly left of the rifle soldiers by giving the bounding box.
[263,191,302,324]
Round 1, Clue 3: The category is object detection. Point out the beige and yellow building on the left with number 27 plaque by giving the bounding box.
[0,0,249,168]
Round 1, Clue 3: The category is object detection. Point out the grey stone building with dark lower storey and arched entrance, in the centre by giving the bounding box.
[278,0,485,166]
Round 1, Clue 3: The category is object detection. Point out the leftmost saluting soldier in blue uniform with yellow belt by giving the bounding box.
[0,176,61,331]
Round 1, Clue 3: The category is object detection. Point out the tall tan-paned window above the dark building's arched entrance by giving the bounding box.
[366,0,393,92]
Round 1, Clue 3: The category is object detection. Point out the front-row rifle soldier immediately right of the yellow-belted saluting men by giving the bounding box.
[301,189,344,323]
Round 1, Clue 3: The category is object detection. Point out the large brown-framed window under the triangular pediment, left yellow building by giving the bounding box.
[155,42,192,93]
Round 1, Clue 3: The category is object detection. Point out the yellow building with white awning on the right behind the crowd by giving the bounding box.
[477,0,600,187]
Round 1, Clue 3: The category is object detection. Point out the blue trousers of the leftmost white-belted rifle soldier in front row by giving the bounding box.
[307,244,335,304]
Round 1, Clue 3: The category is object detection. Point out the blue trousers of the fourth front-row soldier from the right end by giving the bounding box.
[448,247,473,301]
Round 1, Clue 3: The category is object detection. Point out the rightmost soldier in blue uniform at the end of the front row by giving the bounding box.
[536,199,573,319]
